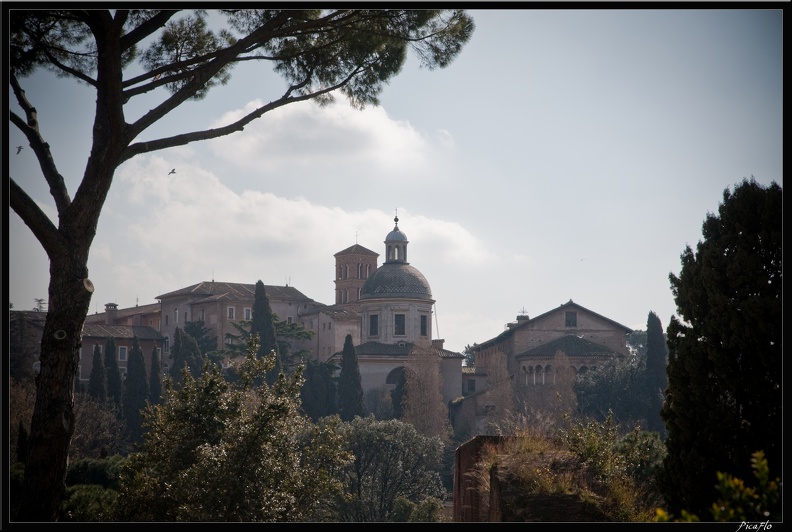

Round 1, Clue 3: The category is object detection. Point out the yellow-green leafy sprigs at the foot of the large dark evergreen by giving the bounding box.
[655,451,783,528]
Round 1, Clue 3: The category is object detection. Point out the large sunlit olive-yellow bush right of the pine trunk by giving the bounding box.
[118,341,350,522]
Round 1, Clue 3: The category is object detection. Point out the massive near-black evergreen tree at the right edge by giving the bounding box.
[658,179,783,516]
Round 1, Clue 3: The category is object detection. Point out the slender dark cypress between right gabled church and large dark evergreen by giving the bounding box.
[644,312,668,438]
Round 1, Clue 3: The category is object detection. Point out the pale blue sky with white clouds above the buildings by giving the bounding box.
[5,8,783,352]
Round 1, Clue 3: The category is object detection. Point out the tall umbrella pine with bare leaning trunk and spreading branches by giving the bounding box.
[7,9,474,521]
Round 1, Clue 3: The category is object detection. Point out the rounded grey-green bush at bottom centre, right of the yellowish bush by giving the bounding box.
[331,416,444,522]
